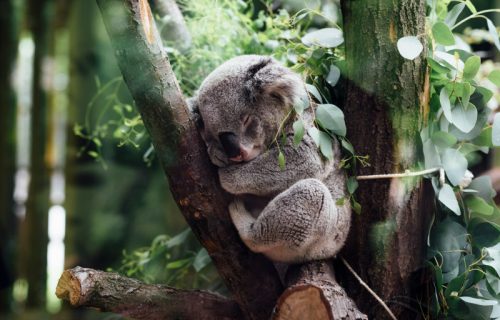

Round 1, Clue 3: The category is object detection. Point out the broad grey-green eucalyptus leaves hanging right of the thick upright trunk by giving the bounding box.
[398,0,500,319]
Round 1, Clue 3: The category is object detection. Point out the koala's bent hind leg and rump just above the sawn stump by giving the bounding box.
[229,179,350,263]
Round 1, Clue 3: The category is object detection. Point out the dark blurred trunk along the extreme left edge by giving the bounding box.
[0,0,20,311]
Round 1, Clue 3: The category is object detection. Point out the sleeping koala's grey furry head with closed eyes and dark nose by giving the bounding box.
[192,55,307,167]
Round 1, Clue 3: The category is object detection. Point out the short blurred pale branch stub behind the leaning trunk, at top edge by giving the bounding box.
[151,0,191,51]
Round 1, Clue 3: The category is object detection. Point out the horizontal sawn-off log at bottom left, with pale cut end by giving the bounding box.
[56,267,242,320]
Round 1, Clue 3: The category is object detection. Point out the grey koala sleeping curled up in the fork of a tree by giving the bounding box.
[190,55,351,263]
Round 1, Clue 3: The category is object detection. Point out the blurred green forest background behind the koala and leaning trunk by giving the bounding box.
[0,0,500,319]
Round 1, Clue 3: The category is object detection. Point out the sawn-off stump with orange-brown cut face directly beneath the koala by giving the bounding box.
[273,261,368,320]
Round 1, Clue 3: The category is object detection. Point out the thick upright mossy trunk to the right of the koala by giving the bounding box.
[342,0,429,319]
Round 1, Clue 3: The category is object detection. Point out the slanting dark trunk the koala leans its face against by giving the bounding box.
[98,0,282,319]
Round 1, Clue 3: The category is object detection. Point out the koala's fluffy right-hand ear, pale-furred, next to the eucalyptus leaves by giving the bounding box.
[245,57,307,106]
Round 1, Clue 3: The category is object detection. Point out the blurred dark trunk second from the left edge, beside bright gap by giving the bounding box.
[20,0,53,308]
